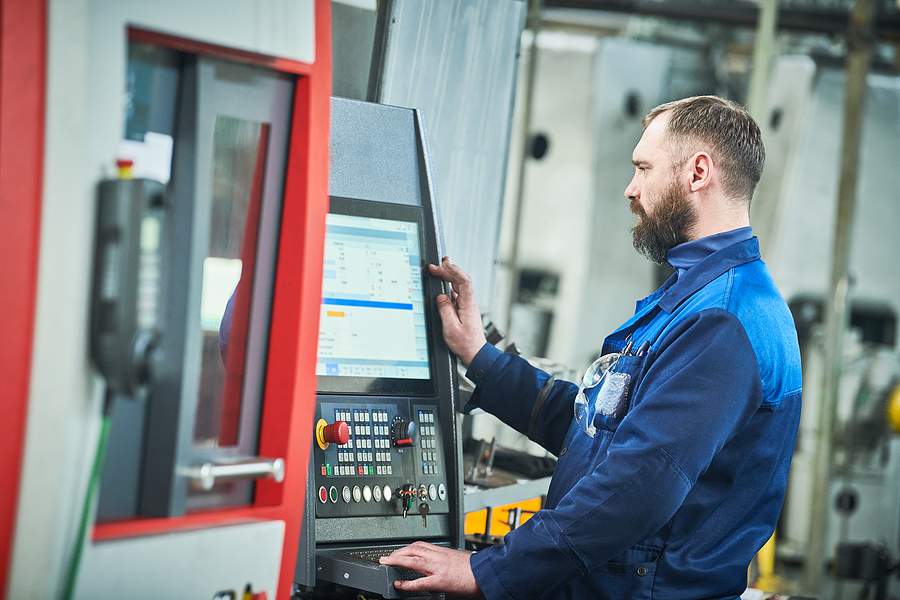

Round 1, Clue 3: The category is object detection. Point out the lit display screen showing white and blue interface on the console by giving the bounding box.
[316,207,431,384]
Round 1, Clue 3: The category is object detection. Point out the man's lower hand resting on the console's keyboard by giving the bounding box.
[380,542,481,598]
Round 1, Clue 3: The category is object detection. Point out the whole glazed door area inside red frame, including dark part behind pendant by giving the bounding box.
[99,44,295,520]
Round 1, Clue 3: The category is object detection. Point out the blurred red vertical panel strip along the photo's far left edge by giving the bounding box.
[0,0,47,596]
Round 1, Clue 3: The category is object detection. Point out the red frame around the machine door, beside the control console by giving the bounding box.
[93,0,331,599]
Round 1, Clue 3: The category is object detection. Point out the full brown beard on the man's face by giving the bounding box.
[631,181,697,264]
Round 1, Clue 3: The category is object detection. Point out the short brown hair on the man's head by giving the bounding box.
[641,96,766,203]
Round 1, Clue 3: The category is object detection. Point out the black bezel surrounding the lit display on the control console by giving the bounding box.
[316,196,436,396]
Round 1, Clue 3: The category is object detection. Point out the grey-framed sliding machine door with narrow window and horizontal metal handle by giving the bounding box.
[141,58,293,515]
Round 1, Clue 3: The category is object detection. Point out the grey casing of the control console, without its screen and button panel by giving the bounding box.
[295,98,463,587]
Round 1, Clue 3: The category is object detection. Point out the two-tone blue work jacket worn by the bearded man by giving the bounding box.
[468,227,801,600]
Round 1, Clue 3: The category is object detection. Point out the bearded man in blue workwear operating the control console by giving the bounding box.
[383,96,801,600]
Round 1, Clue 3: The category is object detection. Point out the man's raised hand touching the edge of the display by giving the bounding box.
[428,256,487,365]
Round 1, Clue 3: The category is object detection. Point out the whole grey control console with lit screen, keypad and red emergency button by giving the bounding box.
[295,99,463,598]
